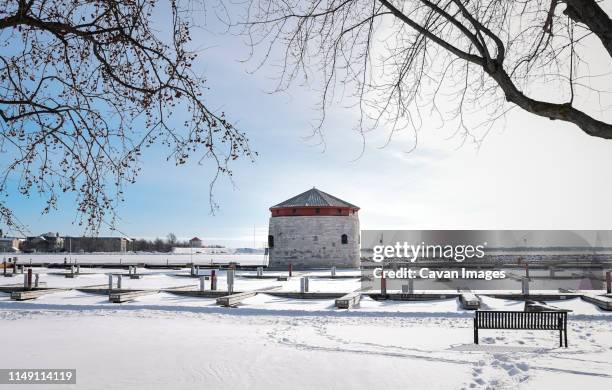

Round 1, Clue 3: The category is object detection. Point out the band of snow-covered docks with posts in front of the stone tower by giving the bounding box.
[0,267,612,313]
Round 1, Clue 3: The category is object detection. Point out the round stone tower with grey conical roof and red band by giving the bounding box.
[268,187,360,268]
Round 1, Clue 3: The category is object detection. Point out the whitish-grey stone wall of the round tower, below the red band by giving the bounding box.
[269,213,360,269]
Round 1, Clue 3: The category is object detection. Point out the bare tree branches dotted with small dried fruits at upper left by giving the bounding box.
[0,0,253,233]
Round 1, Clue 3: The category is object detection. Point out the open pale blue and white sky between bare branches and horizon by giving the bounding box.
[8,2,612,247]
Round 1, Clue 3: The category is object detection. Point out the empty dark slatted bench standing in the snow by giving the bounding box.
[474,310,567,348]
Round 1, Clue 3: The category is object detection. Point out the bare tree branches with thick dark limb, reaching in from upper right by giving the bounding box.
[233,0,612,150]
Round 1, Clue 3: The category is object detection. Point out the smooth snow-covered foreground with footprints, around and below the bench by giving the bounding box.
[0,308,612,390]
